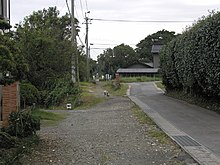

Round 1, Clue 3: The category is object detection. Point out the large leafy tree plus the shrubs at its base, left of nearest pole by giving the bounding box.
[14,7,82,107]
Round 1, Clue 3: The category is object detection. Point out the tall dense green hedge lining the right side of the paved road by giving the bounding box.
[160,12,220,99]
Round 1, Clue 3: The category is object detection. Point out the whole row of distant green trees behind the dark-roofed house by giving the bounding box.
[98,30,177,75]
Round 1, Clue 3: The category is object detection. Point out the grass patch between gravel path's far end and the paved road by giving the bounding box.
[102,81,128,96]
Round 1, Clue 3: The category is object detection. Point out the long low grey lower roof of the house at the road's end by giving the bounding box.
[117,68,158,73]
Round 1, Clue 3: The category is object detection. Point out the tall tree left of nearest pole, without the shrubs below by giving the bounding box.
[15,7,78,88]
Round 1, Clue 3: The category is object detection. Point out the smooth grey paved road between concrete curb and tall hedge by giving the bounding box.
[130,83,220,164]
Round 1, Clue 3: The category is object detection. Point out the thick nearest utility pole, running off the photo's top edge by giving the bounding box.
[71,0,79,83]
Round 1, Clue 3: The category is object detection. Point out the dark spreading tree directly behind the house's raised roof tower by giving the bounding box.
[136,29,176,62]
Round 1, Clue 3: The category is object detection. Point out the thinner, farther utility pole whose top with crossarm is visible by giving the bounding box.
[85,11,90,81]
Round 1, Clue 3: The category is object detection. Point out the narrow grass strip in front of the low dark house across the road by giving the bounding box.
[120,76,162,83]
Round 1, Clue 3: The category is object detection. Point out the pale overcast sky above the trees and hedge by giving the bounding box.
[11,0,220,59]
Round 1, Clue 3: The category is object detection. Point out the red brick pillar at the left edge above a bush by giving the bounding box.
[2,82,20,127]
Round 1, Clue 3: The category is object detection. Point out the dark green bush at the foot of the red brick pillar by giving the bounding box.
[5,110,40,138]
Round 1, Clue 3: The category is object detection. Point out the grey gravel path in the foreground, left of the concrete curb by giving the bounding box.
[22,84,194,165]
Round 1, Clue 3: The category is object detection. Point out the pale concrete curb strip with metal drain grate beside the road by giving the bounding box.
[127,86,220,165]
